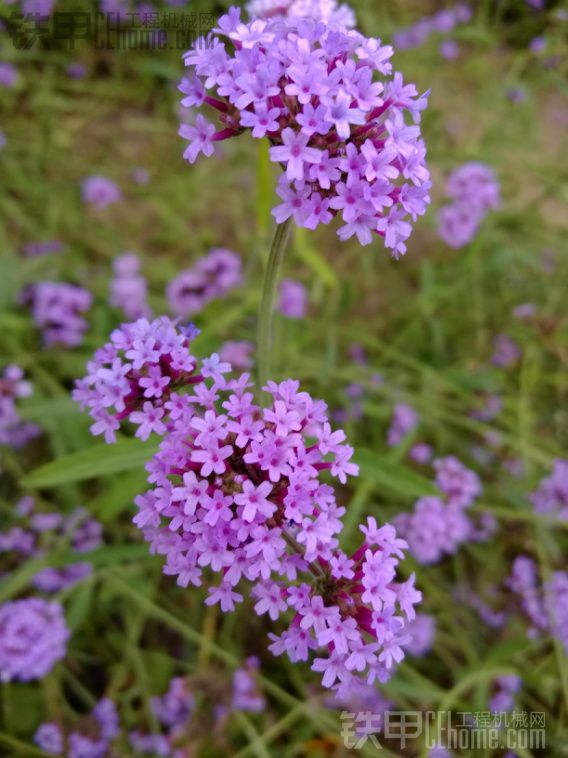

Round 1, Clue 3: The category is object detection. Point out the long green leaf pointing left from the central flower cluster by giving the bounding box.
[22,440,157,488]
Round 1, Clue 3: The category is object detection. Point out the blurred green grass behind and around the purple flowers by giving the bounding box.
[0,0,568,757]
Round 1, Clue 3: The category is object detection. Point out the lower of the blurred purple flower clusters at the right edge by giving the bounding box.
[507,555,568,655]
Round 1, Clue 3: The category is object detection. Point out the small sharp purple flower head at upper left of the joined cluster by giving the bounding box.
[73,317,215,442]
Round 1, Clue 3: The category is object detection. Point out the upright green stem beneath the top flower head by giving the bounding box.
[257,218,292,387]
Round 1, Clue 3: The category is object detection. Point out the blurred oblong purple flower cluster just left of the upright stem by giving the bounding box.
[166,247,242,316]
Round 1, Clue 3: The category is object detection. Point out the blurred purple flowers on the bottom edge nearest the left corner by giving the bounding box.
[34,697,120,758]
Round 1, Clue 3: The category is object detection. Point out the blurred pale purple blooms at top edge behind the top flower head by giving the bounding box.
[246,0,356,29]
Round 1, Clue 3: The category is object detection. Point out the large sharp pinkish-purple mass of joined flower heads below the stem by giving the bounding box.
[76,319,421,694]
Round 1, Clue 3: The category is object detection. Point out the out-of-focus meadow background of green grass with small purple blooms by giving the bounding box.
[0,0,568,758]
